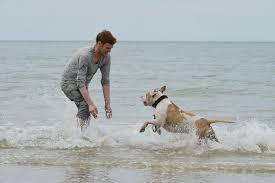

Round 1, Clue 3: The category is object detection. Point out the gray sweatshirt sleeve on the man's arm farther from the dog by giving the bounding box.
[76,56,88,89]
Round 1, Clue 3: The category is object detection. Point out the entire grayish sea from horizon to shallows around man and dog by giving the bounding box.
[0,42,275,182]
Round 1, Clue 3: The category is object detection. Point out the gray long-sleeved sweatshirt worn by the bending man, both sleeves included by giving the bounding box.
[61,47,111,91]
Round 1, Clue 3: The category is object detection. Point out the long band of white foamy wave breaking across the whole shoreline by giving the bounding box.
[0,120,275,154]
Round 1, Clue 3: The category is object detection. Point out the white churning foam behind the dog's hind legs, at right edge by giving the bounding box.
[214,119,275,153]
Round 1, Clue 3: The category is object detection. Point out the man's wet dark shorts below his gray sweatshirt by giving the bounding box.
[62,85,90,121]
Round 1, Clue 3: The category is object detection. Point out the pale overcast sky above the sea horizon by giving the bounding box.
[0,0,275,41]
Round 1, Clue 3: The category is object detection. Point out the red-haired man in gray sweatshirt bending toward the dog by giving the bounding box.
[61,30,116,130]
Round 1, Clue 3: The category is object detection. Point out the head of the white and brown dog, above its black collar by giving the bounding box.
[141,86,166,106]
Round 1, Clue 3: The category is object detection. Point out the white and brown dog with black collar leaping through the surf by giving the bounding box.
[140,86,234,142]
